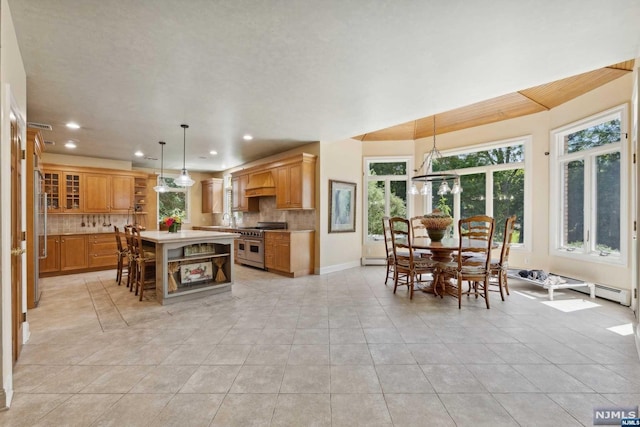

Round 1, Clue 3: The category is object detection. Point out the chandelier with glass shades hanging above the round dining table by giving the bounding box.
[409,114,462,196]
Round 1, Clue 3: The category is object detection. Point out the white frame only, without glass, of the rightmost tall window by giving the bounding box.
[549,104,629,266]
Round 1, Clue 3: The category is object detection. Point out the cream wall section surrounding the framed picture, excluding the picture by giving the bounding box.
[316,139,363,274]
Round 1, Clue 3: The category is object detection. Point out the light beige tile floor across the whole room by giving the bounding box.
[0,267,640,426]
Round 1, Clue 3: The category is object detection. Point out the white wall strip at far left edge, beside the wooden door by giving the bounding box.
[0,0,27,408]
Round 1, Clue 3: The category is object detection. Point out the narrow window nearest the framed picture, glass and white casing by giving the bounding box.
[364,157,412,242]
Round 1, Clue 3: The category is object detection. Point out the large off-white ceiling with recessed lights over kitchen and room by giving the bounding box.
[8,0,640,171]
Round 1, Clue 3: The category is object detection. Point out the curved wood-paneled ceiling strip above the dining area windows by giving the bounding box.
[354,60,634,141]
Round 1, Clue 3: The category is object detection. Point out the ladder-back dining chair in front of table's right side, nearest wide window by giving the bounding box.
[440,215,494,309]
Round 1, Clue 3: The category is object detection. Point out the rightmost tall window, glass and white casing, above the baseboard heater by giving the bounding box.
[549,105,629,264]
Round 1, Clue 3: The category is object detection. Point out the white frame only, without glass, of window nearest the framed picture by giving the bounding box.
[362,156,413,244]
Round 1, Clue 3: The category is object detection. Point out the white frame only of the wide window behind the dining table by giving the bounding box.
[424,135,533,251]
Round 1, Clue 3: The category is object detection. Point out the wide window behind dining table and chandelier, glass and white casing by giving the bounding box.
[425,136,531,249]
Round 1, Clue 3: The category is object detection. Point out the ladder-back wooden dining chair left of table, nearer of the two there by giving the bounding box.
[389,217,436,299]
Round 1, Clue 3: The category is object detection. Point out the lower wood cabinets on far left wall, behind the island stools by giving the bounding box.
[40,233,118,276]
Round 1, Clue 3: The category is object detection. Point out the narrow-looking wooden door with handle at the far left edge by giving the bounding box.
[11,113,24,363]
